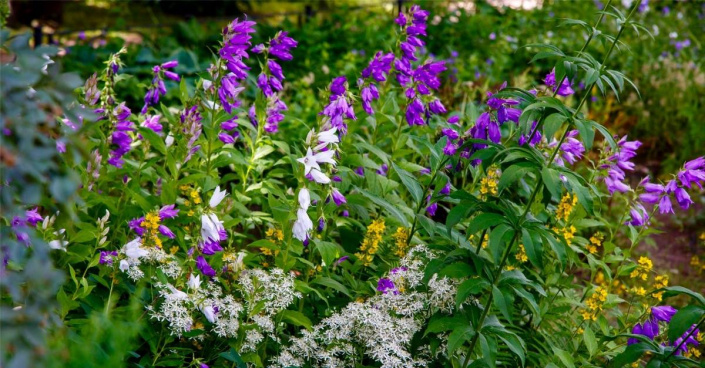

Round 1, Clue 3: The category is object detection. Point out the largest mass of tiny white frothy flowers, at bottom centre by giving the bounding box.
[274,245,432,368]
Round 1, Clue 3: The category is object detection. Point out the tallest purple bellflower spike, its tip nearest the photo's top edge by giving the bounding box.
[394,5,446,126]
